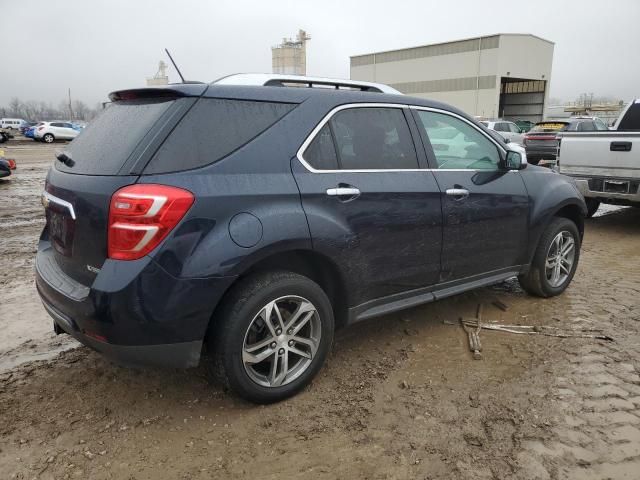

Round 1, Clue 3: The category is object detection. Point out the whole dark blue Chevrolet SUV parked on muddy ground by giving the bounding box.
[36,76,586,402]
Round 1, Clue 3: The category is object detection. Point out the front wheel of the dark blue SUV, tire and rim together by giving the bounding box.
[518,217,580,297]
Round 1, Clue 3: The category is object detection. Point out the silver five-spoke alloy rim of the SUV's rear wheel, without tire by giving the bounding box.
[242,296,322,387]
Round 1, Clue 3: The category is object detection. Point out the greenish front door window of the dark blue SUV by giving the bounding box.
[417,110,500,170]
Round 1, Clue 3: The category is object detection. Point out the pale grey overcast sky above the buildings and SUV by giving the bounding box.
[0,0,640,106]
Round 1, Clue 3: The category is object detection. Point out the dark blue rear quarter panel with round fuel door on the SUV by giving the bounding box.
[139,102,311,278]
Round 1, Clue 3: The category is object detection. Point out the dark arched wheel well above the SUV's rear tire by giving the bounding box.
[214,250,349,328]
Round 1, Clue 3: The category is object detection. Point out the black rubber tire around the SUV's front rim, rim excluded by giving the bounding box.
[518,217,581,298]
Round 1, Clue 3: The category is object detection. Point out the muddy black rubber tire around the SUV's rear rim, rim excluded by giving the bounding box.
[207,271,334,403]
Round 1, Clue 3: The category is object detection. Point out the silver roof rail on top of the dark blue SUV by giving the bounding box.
[212,73,402,95]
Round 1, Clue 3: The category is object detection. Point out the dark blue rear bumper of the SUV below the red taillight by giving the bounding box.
[36,242,234,368]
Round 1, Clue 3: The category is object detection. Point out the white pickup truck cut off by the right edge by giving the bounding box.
[556,99,640,217]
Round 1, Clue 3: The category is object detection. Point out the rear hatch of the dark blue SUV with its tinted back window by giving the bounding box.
[43,85,206,285]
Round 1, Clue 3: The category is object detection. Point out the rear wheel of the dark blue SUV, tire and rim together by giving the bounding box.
[207,272,334,403]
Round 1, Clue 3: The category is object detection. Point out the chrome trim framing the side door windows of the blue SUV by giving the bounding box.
[296,102,515,173]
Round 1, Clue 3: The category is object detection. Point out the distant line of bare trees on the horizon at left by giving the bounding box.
[0,97,102,122]
